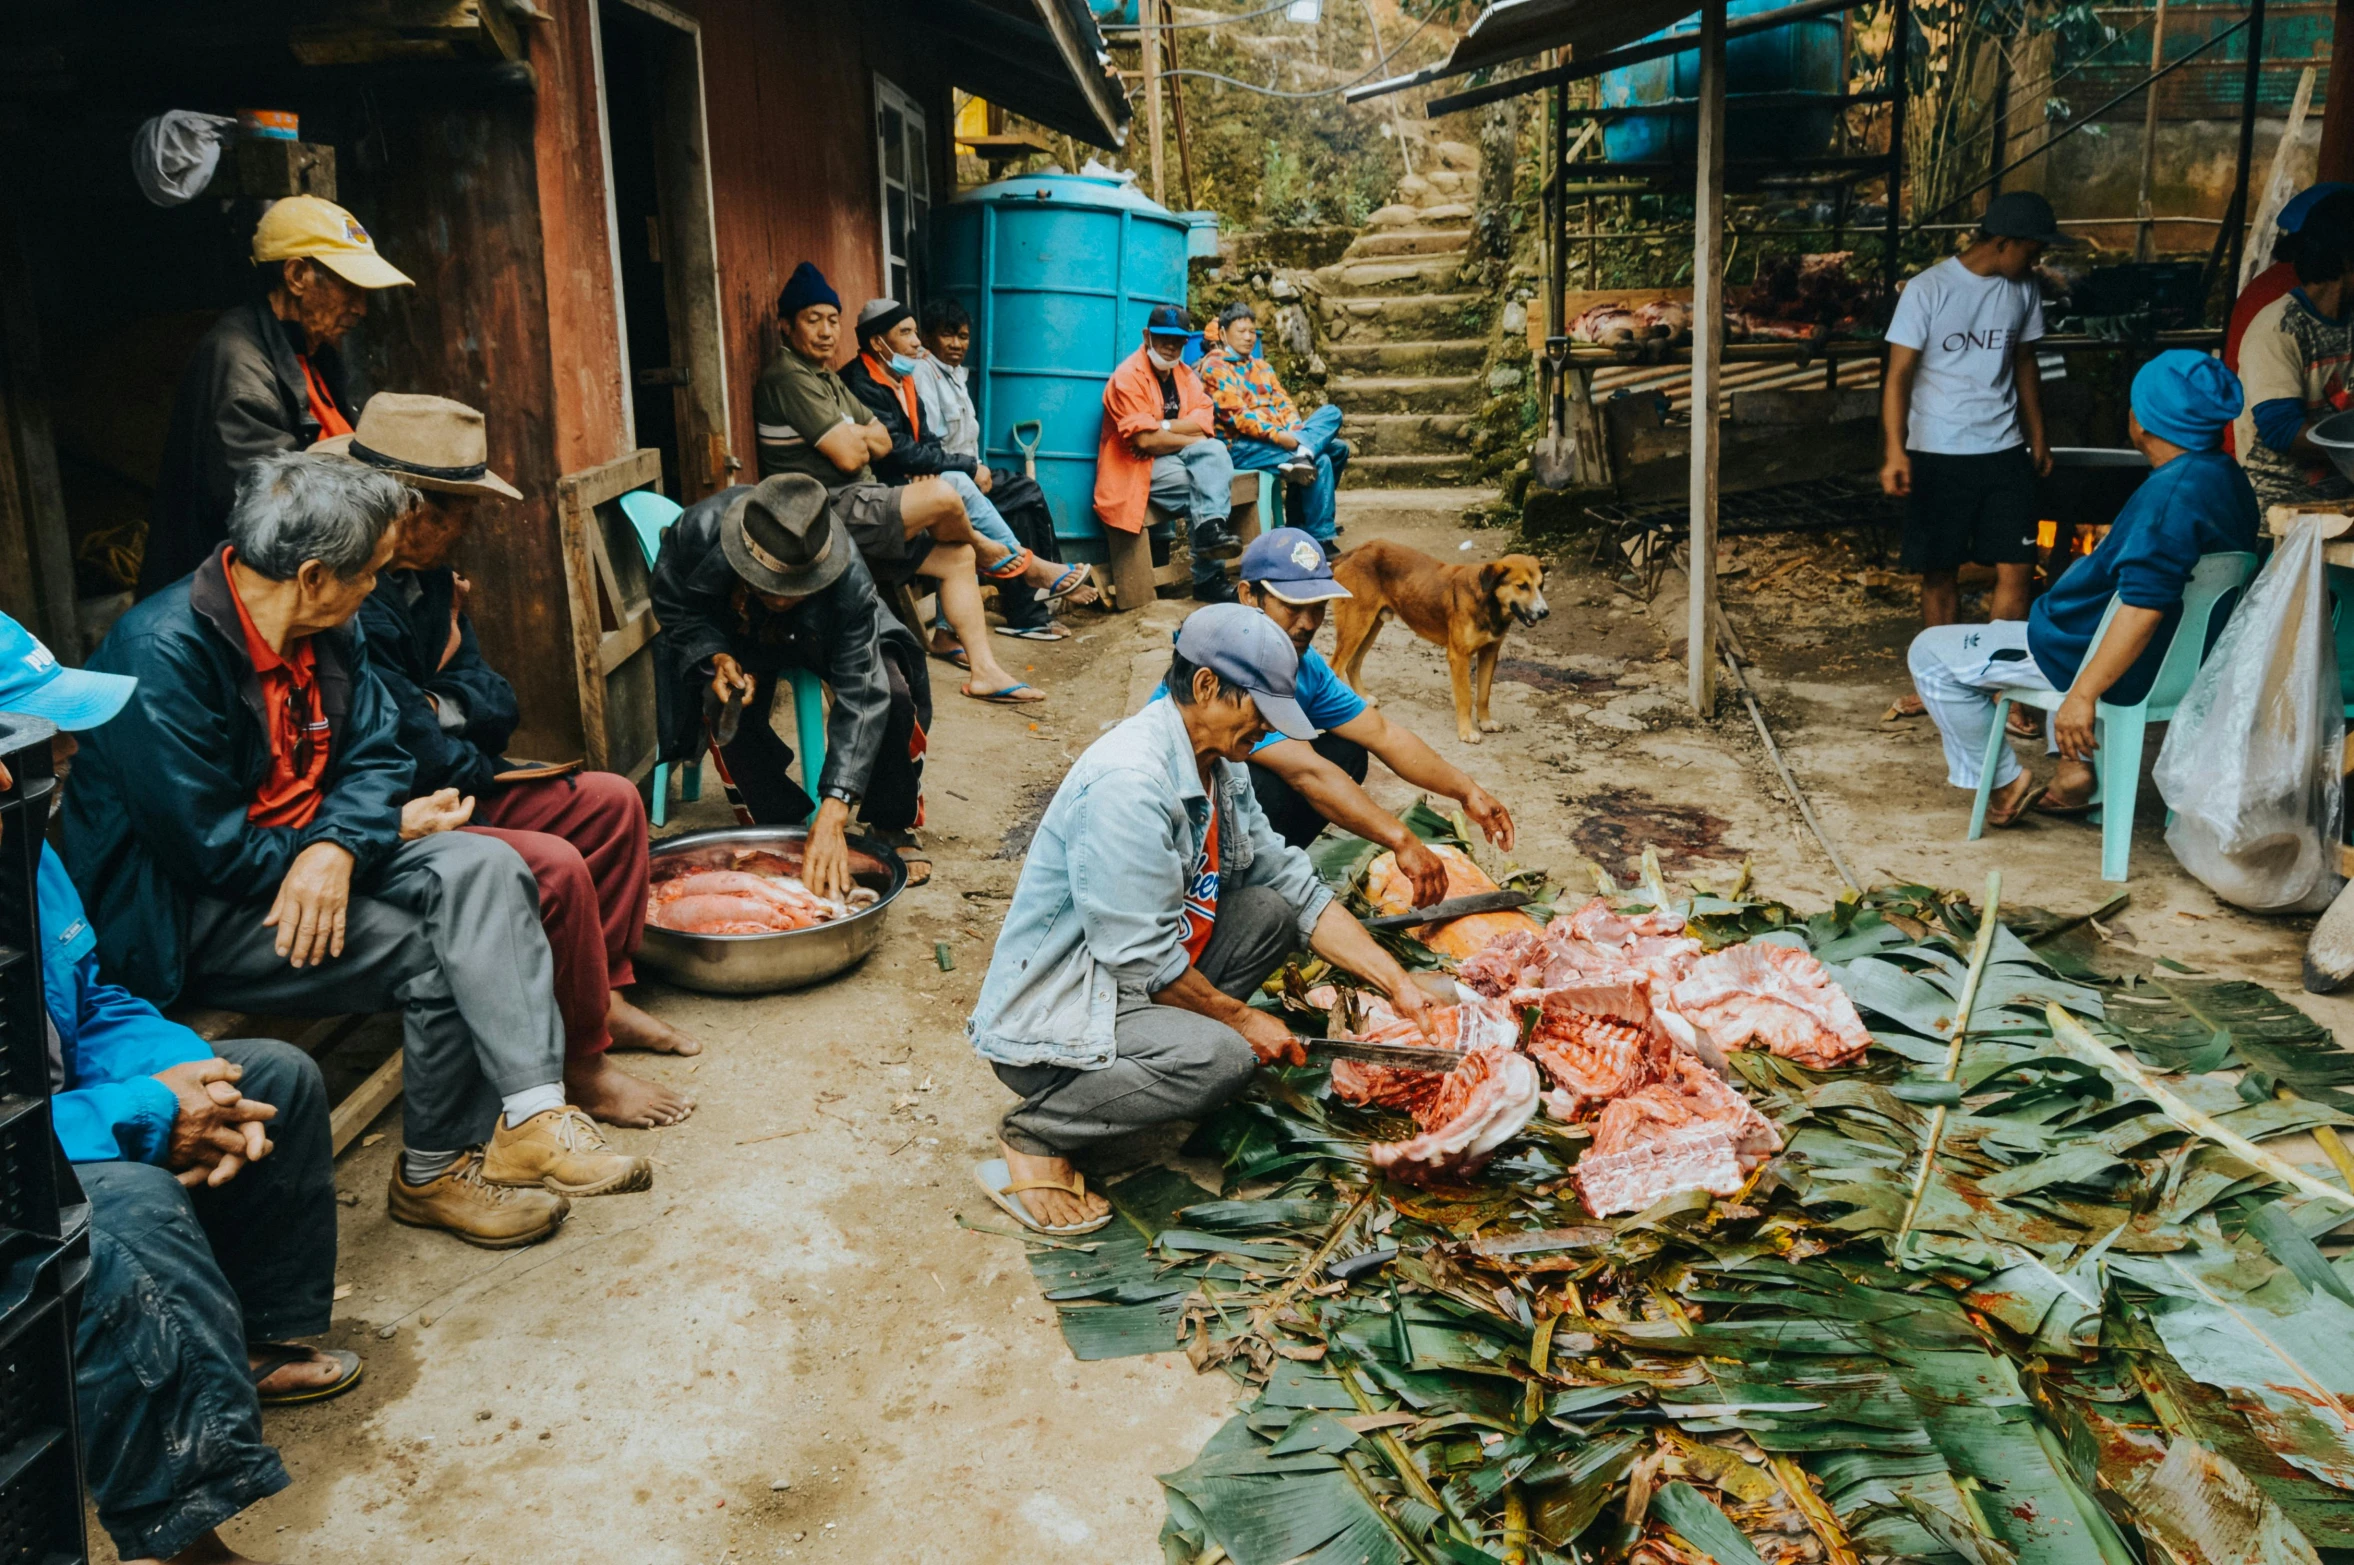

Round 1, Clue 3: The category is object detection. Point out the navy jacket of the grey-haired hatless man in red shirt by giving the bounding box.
[64,551,414,1005]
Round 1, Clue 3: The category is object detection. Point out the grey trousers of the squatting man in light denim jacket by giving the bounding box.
[996,885,1299,1158]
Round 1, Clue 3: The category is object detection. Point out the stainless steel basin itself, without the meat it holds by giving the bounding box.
[638,826,906,995]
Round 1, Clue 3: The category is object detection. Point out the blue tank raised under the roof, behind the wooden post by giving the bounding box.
[1598,0,1843,162]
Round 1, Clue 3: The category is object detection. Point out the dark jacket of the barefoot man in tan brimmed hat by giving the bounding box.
[360,570,520,798]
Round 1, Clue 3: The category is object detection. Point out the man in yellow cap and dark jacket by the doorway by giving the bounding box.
[139,195,410,598]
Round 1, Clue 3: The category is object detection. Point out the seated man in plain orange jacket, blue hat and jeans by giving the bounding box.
[1095,304,1243,602]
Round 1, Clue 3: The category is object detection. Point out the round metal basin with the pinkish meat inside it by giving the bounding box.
[638,826,906,995]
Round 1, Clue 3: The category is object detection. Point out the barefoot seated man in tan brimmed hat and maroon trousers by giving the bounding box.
[336,391,701,1127]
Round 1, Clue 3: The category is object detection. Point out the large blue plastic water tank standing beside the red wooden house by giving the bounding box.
[930,174,1191,560]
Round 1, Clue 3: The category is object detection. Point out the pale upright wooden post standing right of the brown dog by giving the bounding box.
[1685,0,1732,718]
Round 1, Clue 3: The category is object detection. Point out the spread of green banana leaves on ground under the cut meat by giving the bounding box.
[1007,814,2354,1565]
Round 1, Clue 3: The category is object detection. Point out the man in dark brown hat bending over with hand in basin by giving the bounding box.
[654,473,932,897]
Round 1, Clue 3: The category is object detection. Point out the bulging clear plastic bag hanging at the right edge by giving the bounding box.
[2156,520,2345,913]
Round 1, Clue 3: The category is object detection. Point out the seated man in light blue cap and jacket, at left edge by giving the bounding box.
[0,614,360,1560]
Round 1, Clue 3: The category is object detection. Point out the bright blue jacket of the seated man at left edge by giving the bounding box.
[40,843,212,1163]
